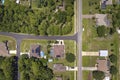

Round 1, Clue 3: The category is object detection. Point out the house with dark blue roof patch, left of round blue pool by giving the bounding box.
[30,45,41,58]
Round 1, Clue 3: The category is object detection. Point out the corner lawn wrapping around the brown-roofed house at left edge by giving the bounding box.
[0,35,16,50]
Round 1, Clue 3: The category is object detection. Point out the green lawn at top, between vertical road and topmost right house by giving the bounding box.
[83,0,100,14]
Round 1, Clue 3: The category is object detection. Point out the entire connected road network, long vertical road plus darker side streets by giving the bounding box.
[0,0,82,80]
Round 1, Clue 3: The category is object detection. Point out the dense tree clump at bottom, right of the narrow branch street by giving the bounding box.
[19,55,54,80]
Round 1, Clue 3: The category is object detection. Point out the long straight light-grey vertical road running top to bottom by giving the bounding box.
[76,0,82,80]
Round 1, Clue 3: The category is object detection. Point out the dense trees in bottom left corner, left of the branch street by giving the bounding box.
[0,56,18,80]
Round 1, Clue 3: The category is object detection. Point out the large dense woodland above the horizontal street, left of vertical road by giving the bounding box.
[0,0,74,35]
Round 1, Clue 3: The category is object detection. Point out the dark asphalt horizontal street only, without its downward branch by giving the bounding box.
[0,32,77,41]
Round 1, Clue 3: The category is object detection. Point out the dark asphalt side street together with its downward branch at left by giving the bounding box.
[0,32,77,80]
